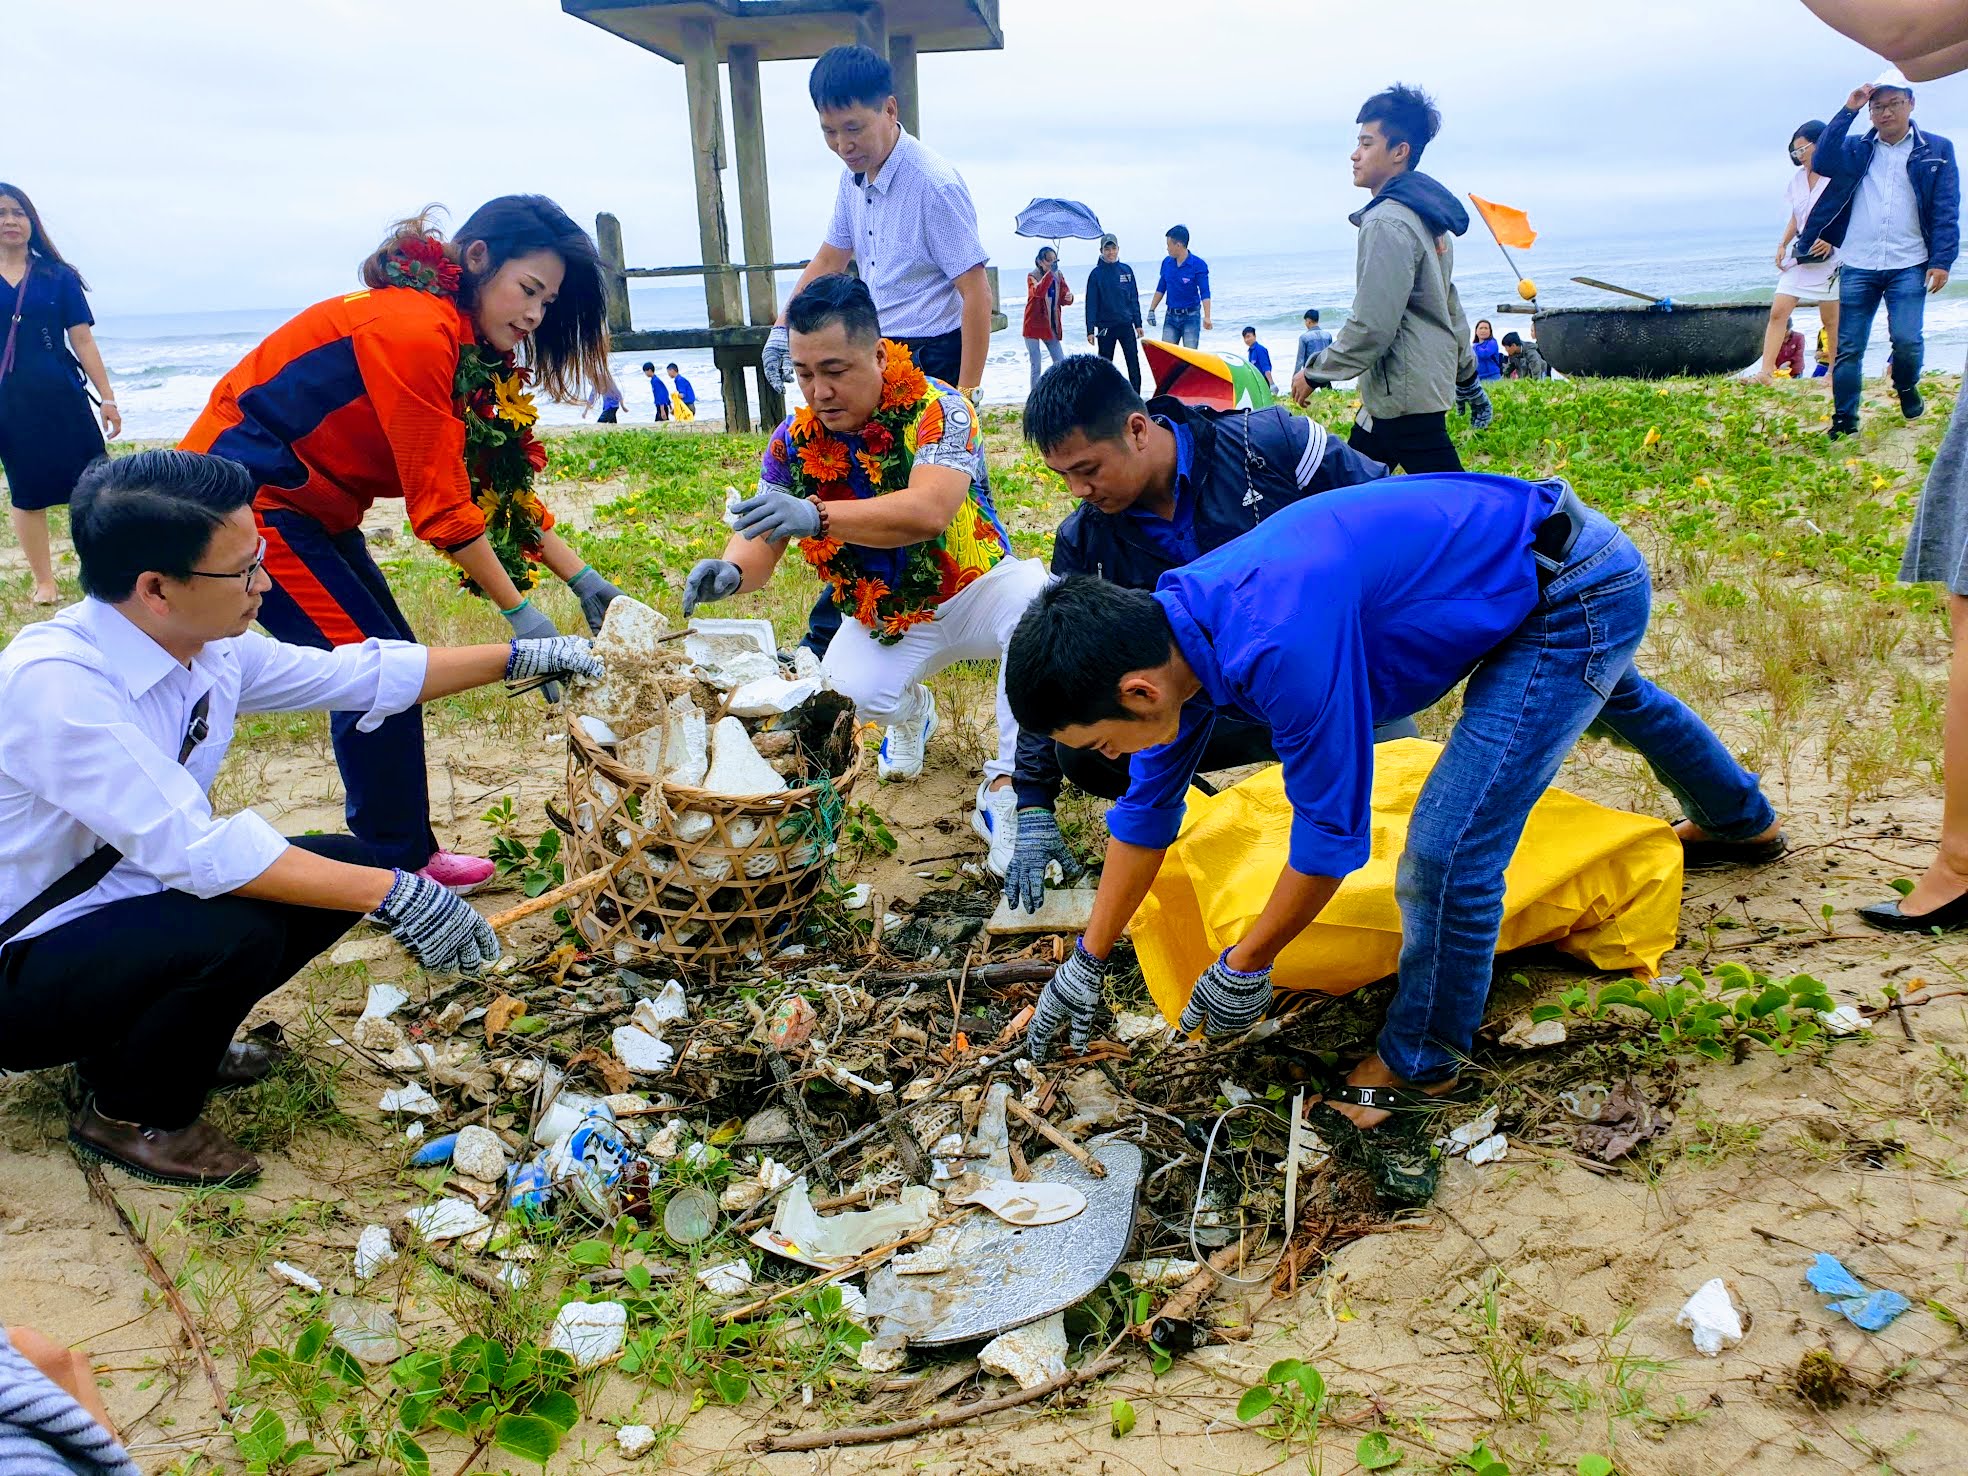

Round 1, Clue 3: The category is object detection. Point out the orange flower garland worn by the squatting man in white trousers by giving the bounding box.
[787,350,951,646]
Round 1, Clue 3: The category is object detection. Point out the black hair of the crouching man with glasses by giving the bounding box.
[69,451,254,604]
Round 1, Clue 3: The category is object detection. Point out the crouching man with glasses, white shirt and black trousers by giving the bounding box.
[0,451,600,1185]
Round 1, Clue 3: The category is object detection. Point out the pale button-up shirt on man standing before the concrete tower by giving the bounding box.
[827,128,990,338]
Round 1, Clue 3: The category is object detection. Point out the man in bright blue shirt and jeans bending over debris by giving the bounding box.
[1006,472,1783,1204]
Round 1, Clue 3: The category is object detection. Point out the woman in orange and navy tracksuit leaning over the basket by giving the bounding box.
[183,195,620,892]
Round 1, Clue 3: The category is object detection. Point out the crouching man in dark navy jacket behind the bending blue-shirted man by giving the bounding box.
[990,354,1419,911]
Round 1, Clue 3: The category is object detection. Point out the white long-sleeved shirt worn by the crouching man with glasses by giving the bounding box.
[0,600,429,939]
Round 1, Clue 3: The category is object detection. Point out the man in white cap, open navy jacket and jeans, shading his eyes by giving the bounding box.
[1799,71,1962,441]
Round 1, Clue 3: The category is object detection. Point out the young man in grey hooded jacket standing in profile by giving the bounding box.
[1291,85,1490,472]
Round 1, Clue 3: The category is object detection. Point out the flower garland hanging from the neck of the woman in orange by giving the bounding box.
[384,236,547,594]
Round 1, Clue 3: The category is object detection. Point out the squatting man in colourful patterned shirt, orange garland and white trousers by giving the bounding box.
[683,276,1045,876]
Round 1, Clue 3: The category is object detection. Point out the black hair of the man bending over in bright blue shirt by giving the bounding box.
[1004,582,1175,734]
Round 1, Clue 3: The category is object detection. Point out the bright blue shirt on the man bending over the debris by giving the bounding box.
[1108,474,1561,876]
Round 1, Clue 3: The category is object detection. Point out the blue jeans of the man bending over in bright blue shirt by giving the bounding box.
[1380,512,1777,1082]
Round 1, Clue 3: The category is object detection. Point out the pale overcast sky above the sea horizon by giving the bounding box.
[0,0,1968,315]
